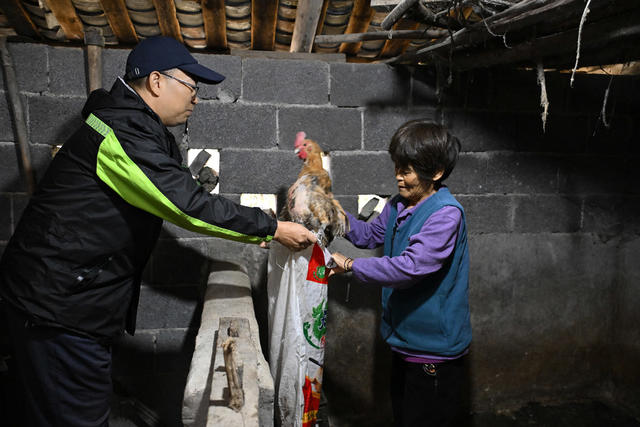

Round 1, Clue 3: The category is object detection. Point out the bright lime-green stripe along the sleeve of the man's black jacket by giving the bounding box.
[86,114,273,243]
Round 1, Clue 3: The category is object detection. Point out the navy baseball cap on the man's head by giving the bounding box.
[125,36,225,84]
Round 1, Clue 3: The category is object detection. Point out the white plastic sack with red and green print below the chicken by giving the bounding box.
[267,242,331,427]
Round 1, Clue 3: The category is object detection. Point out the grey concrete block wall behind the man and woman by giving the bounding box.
[0,40,640,425]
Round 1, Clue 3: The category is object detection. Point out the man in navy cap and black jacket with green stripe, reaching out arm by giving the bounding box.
[0,37,315,427]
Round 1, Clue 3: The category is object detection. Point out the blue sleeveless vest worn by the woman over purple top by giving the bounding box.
[380,187,471,356]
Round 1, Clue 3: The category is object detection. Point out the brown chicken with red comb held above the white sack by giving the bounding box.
[282,132,348,247]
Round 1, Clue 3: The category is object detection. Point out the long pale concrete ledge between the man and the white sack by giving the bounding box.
[182,262,274,427]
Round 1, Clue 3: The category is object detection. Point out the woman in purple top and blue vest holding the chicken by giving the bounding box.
[331,120,471,426]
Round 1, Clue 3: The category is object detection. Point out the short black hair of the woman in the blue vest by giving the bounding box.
[389,119,461,186]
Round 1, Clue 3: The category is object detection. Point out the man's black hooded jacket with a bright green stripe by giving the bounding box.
[0,80,277,338]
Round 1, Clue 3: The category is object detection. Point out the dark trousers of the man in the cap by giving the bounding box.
[2,304,112,427]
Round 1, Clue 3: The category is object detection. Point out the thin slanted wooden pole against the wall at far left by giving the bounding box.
[0,37,36,195]
